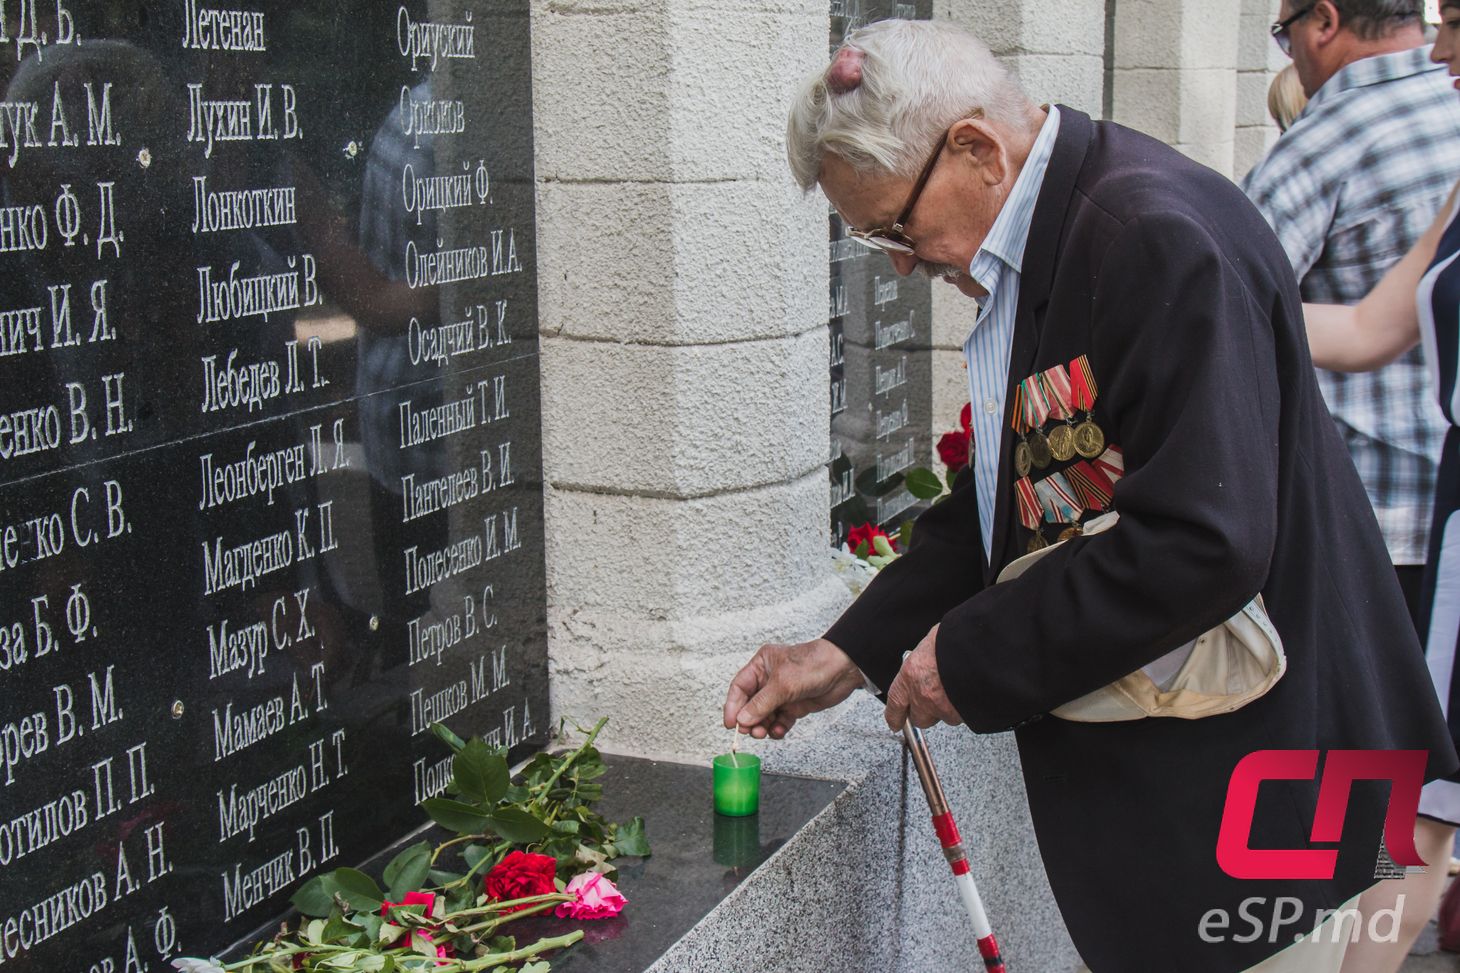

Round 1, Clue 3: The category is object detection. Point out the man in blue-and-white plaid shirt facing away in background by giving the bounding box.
[1242,0,1460,615]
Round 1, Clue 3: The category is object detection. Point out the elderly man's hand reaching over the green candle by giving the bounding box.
[726,638,861,739]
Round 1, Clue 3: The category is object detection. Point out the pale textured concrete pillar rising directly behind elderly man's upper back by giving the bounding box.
[1113,0,1244,175]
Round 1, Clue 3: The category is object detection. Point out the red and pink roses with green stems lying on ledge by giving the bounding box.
[172,720,650,973]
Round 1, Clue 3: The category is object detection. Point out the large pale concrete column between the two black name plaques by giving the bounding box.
[533,0,848,758]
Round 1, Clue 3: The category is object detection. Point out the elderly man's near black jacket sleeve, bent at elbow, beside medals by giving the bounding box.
[934,213,1279,732]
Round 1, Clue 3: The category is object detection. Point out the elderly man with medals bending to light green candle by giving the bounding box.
[724,22,1457,973]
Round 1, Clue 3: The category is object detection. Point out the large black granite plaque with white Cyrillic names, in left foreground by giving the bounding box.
[0,0,548,973]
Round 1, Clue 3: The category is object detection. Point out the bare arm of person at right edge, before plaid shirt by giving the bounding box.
[1302,190,1456,371]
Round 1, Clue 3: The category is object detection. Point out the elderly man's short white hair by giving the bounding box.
[785,20,1032,190]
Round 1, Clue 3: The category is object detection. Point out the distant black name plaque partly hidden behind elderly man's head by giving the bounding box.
[828,0,928,545]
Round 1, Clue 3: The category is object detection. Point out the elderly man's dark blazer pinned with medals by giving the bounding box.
[826,107,1457,973]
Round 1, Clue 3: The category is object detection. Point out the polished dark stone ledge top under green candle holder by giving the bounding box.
[512,755,847,973]
